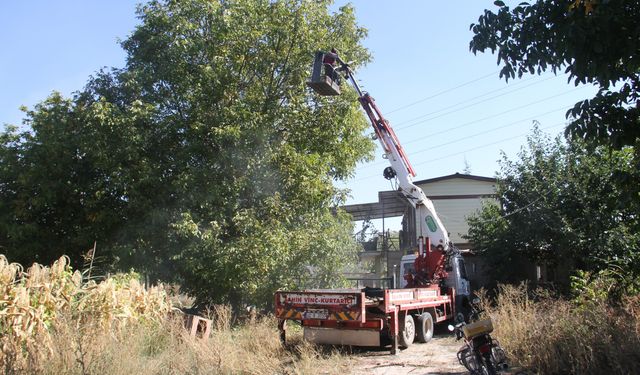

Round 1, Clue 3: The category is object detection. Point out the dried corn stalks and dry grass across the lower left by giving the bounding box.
[0,255,349,374]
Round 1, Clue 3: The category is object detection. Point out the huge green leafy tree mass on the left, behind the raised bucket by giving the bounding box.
[0,0,373,303]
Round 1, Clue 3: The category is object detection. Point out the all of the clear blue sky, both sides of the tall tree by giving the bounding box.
[0,0,595,231]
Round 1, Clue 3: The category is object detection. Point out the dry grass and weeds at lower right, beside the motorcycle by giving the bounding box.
[484,285,640,374]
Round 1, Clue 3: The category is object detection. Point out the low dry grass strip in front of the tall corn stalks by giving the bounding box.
[41,317,348,375]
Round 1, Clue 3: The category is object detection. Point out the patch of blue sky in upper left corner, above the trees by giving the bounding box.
[0,0,137,125]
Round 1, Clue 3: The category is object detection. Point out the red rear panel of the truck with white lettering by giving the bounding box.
[275,291,365,323]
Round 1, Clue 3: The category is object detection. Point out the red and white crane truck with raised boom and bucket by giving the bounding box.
[275,51,470,354]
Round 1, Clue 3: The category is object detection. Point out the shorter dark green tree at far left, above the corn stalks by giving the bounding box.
[0,97,137,264]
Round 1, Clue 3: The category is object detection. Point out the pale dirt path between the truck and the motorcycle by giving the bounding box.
[351,334,467,375]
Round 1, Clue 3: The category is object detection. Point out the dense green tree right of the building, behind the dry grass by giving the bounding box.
[468,131,640,290]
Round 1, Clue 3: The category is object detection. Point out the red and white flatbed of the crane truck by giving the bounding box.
[275,286,455,353]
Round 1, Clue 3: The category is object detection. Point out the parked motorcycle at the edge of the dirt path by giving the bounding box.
[449,298,508,375]
